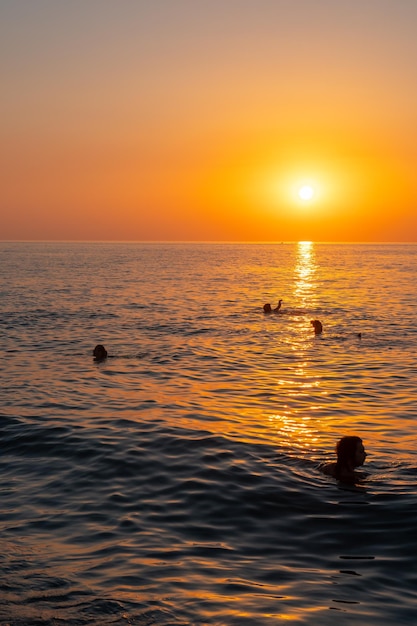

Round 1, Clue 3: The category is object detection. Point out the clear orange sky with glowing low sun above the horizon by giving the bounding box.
[0,0,417,242]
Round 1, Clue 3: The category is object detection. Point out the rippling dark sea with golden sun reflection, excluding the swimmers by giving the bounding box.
[0,242,417,626]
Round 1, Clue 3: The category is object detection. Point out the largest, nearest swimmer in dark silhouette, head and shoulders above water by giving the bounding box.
[320,435,367,483]
